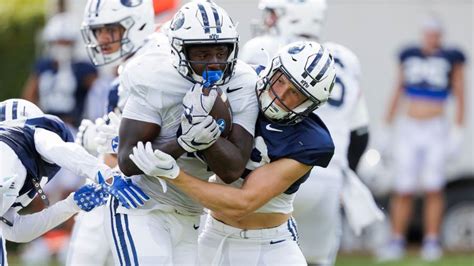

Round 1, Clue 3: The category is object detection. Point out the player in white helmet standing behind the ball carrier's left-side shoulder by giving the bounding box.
[66,0,155,265]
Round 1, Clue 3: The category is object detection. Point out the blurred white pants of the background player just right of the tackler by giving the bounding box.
[293,167,343,265]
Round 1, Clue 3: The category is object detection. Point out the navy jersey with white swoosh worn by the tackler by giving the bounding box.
[242,113,334,194]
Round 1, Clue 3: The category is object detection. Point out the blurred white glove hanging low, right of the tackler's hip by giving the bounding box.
[342,169,385,236]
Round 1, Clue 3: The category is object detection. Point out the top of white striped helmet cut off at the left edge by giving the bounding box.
[0,99,44,123]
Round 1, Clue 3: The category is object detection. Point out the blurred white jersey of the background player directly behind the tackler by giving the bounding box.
[241,35,369,167]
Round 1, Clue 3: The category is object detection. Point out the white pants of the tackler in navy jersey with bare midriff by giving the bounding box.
[199,215,306,266]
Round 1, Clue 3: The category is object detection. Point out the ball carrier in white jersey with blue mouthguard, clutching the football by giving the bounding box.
[102,1,258,264]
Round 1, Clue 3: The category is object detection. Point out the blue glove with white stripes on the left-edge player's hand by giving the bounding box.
[97,172,150,209]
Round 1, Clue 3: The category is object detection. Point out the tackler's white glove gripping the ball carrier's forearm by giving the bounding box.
[129,141,180,192]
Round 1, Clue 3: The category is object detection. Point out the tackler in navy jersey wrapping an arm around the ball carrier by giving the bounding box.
[132,42,336,265]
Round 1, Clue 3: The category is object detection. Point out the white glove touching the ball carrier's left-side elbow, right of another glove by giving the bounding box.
[96,112,121,154]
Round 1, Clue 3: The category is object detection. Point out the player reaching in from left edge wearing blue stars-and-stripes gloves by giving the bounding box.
[0,99,148,265]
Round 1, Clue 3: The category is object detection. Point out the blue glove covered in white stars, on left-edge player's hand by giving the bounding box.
[73,184,109,212]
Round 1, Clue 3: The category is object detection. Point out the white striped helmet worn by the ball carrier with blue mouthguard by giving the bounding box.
[167,0,239,85]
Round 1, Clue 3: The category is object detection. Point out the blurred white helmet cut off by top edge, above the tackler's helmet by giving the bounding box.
[259,0,327,40]
